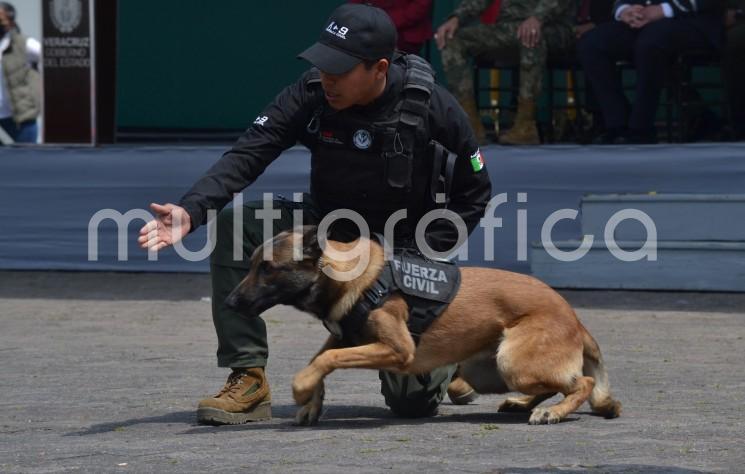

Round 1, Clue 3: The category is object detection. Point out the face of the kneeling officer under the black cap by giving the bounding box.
[321,59,388,110]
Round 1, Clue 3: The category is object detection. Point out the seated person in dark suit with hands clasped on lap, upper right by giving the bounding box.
[577,0,722,143]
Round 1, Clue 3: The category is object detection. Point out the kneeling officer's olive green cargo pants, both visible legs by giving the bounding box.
[210,196,455,417]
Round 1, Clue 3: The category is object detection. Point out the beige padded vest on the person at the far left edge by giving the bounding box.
[3,31,41,124]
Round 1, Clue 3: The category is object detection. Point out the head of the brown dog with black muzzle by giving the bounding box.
[225,226,322,317]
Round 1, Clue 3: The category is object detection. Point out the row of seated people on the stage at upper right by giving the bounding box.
[368,0,745,145]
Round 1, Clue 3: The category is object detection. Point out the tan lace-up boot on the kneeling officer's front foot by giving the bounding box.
[197,367,272,425]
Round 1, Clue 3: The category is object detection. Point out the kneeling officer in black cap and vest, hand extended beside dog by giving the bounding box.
[139,4,491,424]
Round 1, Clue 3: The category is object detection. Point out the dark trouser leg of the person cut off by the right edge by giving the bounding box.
[722,22,745,135]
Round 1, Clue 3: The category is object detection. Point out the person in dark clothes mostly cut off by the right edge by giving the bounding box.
[722,0,745,140]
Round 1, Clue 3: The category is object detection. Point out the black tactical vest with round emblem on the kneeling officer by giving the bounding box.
[306,55,454,241]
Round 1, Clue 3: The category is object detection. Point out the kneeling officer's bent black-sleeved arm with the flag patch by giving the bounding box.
[427,86,491,252]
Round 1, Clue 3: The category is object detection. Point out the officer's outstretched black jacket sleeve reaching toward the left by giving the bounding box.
[179,71,322,230]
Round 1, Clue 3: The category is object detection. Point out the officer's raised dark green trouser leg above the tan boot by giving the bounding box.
[210,201,315,367]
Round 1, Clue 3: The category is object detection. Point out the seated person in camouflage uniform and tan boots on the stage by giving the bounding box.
[435,0,575,145]
